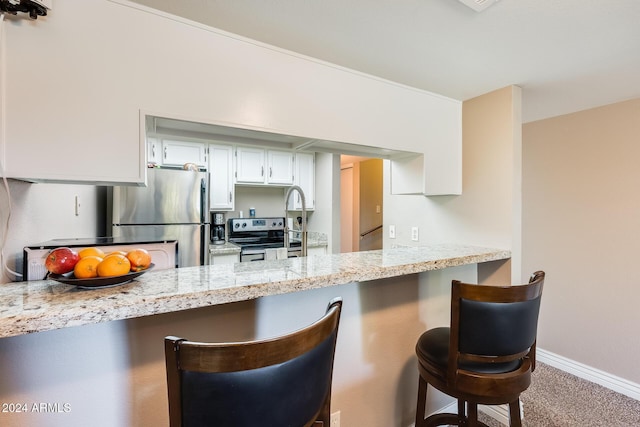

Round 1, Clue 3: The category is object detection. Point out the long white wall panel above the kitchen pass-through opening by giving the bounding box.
[5,0,461,190]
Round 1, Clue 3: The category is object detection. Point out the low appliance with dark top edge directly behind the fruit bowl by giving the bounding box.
[22,237,178,280]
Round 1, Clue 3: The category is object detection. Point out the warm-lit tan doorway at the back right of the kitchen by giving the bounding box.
[340,155,383,253]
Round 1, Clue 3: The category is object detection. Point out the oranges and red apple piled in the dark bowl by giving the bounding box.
[45,247,151,279]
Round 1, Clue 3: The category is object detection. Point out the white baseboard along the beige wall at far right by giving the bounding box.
[536,348,640,400]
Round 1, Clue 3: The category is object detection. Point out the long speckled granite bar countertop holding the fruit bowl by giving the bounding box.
[0,245,511,338]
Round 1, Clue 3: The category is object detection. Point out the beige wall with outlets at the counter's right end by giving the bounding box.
[384,86,516,283]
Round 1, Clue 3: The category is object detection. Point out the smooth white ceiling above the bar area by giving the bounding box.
[127,0,640,122]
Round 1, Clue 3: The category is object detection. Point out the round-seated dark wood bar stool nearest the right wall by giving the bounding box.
[416,271,545,427]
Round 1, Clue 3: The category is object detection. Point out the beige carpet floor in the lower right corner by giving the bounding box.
[481,363,640,427]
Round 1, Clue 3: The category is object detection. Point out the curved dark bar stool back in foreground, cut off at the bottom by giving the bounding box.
[165,298,342,427]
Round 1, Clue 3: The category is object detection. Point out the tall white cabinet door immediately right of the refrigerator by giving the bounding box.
[209,144,235,210]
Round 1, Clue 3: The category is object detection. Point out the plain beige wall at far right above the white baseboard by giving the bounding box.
[523,99,640,382]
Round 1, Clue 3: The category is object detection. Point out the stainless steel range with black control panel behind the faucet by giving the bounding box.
[227,217,302,262]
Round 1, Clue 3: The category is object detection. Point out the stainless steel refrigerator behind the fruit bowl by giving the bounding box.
[112,168,210,267]
